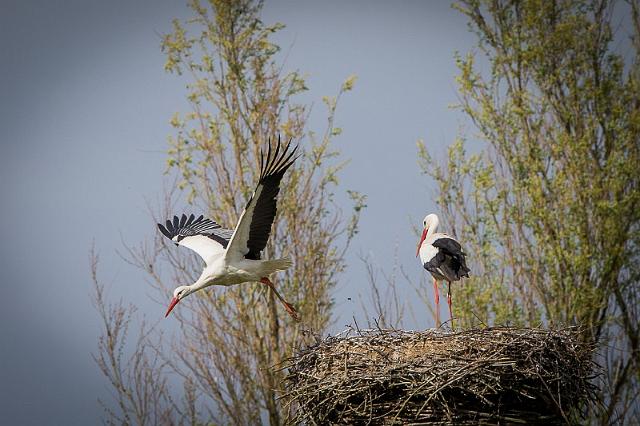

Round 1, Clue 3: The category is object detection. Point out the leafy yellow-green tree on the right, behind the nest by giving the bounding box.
[419,0,640,424]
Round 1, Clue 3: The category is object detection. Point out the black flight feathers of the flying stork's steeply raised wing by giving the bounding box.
[245,137,298,260]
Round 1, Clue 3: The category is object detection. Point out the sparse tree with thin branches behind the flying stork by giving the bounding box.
[95,0,364,425]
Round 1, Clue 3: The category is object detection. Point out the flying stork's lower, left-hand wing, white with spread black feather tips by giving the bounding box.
[158,214,233,264]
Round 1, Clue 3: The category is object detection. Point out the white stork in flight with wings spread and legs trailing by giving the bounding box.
[158,138,298,320]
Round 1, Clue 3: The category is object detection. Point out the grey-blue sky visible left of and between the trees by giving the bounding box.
[0,0,475,425]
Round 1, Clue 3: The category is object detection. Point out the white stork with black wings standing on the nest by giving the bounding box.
[416,213,470,327]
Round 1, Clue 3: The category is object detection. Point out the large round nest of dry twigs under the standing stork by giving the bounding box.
[285,328,595,425]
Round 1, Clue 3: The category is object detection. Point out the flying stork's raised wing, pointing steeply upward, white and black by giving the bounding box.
[226,137,298,260]
